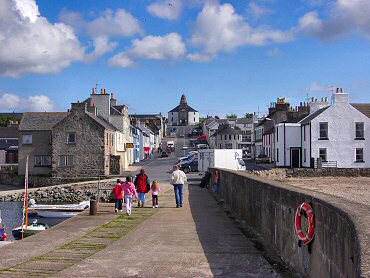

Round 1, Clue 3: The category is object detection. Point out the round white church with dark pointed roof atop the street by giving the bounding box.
[168,94,199,126]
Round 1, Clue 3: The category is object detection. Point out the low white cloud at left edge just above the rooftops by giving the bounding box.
[0,93,55,112]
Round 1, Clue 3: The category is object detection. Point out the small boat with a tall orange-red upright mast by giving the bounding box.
[12,155,49,239]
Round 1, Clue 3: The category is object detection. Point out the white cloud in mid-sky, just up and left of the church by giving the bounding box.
[109,33,186,67]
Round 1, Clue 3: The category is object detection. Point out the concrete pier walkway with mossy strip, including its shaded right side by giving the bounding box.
[0,179,279,277]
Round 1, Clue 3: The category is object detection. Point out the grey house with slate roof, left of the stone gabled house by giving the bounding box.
[18,112,69,176]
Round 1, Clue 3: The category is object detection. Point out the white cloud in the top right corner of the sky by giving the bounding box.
[299,0,370,40]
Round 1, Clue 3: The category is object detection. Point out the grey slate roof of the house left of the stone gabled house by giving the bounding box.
[19,112,69,131]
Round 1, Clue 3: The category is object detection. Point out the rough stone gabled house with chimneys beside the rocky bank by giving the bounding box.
[52,102,117,178]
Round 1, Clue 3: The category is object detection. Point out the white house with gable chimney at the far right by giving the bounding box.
[275,89,370,168]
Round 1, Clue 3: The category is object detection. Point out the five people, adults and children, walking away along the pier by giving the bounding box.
[113,165,187,215]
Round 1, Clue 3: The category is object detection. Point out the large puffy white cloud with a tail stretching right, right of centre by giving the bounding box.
[191,2,293,56]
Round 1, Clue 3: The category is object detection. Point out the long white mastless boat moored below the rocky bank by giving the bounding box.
[28,199,90,218]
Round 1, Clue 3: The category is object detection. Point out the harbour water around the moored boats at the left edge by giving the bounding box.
[0,202,67,240]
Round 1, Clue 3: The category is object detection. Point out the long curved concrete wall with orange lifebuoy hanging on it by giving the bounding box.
[211,169,370,277]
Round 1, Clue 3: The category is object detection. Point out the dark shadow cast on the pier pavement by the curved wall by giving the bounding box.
[189,180,280,277]
